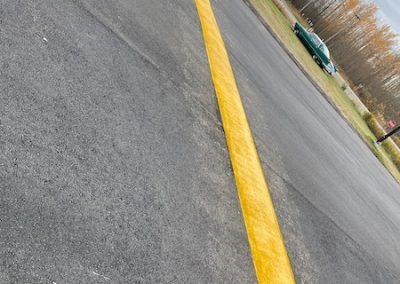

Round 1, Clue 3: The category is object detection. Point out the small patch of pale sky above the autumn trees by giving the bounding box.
[373,0,400,34]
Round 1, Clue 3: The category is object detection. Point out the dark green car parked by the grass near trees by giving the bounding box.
[293,22,336,75]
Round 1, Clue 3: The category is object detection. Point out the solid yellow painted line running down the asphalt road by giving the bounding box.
[195,0,295,284]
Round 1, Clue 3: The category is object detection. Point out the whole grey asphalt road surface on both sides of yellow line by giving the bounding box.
[0,0,400,284]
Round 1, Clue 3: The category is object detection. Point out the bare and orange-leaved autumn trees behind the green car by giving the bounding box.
[291,0,400,120]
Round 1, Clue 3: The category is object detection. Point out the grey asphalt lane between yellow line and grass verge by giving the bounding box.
[214,0,400,283]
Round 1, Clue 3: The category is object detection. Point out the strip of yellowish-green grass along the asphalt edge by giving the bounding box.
[250,0,400,183]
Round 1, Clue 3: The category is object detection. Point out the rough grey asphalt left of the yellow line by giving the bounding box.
[0,0,255,284]
